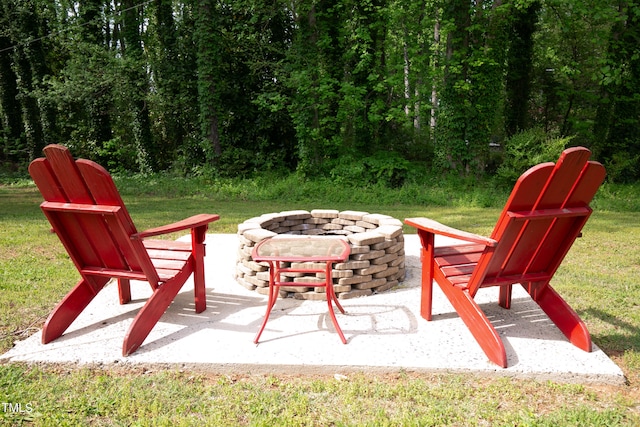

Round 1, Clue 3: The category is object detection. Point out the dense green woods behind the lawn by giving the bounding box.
[0,0,640,182]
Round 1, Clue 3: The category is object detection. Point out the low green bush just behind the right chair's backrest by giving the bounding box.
[496,128,572,186]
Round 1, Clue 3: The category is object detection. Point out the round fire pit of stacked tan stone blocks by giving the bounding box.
[236,209,405,300]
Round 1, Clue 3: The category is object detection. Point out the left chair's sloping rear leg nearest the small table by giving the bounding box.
[122,268,191,356]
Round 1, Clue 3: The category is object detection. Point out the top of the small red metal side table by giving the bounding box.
[251,234,351,262]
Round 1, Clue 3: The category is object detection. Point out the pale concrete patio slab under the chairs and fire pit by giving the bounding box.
[0,234,625,385]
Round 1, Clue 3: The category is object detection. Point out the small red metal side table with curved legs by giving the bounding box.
[251,235,351,344]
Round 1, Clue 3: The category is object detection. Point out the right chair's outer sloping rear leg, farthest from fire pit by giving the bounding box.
[525,284,592,352]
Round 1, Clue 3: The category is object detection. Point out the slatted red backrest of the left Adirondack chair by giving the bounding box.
[29,145,159,288]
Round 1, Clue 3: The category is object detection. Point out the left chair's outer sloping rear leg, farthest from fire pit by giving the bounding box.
[42,277,109,344]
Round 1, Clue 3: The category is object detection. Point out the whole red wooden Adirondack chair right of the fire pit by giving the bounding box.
[405,147,605,368]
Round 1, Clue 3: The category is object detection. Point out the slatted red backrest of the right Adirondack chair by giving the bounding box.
[469,147,605,295]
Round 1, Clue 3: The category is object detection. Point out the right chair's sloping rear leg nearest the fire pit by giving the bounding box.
[440,283,507,368]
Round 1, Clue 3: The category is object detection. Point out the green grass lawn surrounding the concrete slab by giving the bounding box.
[0,177,640,426]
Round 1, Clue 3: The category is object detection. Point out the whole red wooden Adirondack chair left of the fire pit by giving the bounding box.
[29,145,219,356]
